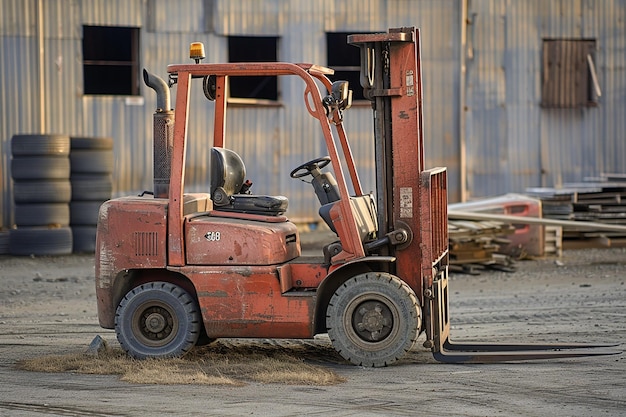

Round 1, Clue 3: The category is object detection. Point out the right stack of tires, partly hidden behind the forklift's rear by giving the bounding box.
[70,137,113,253]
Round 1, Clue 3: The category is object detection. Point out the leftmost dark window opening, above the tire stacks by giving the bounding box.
[83,26,139,95]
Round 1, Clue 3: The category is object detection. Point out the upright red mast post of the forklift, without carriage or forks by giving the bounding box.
[348,28,424,292]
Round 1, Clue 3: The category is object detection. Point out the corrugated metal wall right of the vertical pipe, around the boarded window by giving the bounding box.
[464,0,626,197]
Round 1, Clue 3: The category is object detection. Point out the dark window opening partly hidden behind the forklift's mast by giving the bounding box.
[326,32,365,100]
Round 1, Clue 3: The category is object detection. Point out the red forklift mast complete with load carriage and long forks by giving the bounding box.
[348,28,618,363]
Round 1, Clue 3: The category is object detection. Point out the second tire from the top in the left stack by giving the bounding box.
[11,156,70,181]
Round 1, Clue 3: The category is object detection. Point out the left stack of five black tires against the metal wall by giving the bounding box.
[9,135,72,255]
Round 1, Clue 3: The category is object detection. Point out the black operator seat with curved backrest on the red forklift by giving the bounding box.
[210,148,289,216]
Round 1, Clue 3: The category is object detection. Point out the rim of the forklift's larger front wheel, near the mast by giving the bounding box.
[344,294,399,351]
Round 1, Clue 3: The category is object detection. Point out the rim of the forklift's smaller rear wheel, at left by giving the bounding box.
[132,301,179,347]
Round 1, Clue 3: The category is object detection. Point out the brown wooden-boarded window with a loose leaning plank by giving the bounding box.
[541,39,601,108]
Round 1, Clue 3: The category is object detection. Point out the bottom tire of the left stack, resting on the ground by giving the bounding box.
[9,227,72,256]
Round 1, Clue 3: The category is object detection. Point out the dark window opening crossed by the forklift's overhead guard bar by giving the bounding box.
[228,36,278,101]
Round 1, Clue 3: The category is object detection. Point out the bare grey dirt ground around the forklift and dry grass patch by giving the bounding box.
[0,244,626,417]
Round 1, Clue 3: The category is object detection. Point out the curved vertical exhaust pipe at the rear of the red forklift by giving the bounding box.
[143,69,174,198]
